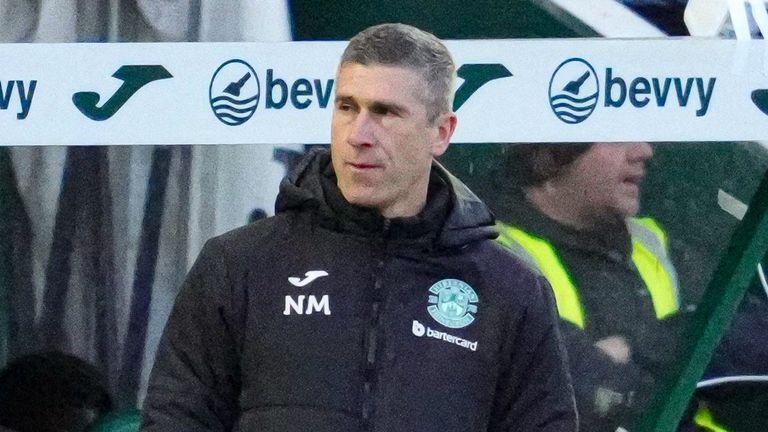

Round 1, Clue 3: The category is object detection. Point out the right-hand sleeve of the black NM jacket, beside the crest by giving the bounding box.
[490,278,578,432]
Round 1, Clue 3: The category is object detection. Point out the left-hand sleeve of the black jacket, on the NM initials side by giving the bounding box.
[141,241,240,432]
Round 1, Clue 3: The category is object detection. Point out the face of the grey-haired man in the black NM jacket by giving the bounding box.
[331,63,456,218]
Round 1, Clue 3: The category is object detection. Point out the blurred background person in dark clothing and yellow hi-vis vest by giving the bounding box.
[498,142,681,432]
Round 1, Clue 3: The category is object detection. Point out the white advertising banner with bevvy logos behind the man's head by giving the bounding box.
[0,39,768,145]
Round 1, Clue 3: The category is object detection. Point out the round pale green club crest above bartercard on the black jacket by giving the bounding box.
[427,279,477,328]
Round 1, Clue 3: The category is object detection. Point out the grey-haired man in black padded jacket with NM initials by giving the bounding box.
[142,24,576,432]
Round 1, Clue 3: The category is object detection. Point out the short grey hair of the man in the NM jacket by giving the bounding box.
[340,24,456,123]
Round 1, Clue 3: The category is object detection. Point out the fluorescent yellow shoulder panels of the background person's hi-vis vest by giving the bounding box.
[497,218,680,329]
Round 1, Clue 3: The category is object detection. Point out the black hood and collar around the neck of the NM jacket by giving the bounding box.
[275,149,498,249]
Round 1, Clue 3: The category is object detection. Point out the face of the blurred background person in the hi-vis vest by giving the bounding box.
[558,142,653,219]
